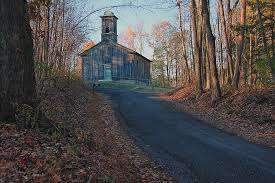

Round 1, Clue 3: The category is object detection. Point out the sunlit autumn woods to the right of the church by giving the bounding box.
[151,0,275,98]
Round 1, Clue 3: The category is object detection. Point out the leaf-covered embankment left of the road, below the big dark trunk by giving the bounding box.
[0,80,172,182]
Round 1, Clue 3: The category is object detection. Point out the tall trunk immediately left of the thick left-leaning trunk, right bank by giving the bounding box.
[190,0,203,95]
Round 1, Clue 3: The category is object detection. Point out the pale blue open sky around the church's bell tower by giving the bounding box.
[86,0,179,59]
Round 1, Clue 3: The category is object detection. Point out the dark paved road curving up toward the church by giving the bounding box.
[99,89,275,183]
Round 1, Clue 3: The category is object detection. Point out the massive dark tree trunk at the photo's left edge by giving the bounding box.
[0,0,35,120]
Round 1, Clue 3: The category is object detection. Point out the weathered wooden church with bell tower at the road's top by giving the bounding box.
[80,11,151,84]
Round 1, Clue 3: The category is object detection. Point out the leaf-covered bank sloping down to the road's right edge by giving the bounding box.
[161,87,275,147]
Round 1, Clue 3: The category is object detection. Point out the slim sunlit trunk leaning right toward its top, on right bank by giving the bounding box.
[232,0,247,88]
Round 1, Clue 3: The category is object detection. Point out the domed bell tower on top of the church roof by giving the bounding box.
[100,10,118,43]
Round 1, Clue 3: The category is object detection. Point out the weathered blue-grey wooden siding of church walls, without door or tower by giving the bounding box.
[82,43,150,83]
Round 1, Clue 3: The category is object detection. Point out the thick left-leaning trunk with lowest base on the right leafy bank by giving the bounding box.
[201,0,221,99]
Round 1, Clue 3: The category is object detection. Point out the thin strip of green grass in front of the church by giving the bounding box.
[99,81,171,93]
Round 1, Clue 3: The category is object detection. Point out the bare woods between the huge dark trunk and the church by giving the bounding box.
[28,0,89,77]
